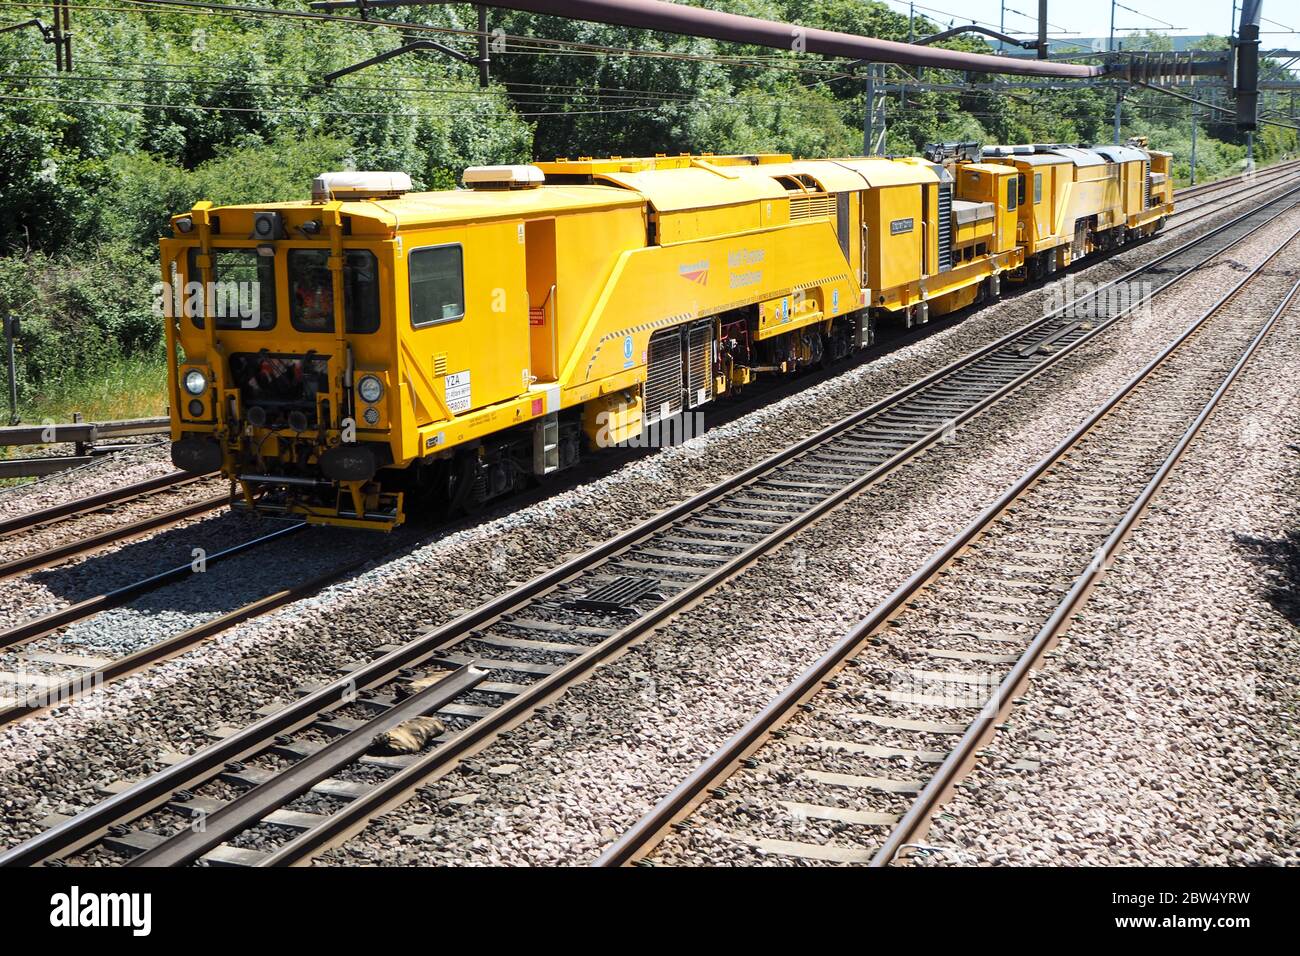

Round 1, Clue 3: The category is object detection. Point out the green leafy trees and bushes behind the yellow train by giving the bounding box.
[0,0,1297,418]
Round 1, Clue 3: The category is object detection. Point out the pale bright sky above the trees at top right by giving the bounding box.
[887,0,1300,49]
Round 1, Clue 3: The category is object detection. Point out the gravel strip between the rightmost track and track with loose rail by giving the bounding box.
[309,205,1300,864]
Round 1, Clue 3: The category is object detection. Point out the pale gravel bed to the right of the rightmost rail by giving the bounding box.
[911,293,1300,866]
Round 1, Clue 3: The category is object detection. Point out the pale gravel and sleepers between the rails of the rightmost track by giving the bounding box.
[650,265,1295,865]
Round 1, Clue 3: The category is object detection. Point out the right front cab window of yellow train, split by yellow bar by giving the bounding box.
[289,248,380,333]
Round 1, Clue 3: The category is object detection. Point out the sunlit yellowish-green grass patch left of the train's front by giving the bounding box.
[0,355,166,424]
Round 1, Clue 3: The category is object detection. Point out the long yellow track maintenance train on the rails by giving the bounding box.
[161,143,1173,528]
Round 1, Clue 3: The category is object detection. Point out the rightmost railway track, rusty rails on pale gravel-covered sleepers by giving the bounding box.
[597,230,1300,866]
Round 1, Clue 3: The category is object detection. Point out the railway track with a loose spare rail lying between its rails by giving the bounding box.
[0,178,1300,865]
